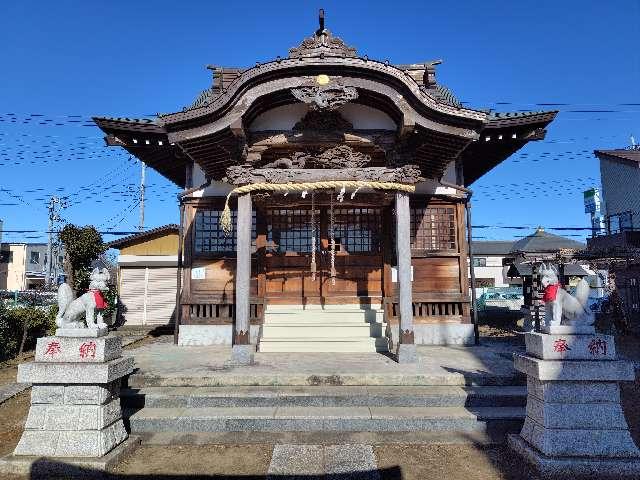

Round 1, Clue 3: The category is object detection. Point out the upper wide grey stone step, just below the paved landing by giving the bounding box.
[121,386,527,408]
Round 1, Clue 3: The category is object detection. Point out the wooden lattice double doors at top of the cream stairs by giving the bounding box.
[265,205,383,304]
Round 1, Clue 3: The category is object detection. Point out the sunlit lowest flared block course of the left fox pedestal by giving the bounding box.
[13,420,127,457]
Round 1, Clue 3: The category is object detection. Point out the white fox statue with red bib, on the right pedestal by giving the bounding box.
[540,263,595,326]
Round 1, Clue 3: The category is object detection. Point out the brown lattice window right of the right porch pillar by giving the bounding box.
[411,205,458,251]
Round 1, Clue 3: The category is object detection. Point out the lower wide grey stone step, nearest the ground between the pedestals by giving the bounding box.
[126,407,525,434]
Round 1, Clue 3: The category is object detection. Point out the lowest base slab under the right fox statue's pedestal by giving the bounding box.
[508,435,640,480]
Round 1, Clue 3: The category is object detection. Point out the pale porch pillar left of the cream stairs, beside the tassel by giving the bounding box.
[232,194,255,364]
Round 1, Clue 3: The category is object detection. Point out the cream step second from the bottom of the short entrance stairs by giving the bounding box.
[262,322,386,341]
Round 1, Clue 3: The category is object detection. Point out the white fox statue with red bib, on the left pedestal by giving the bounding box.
[56,268,111,328]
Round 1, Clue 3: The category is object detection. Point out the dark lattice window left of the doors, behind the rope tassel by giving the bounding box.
[193,210,256,255]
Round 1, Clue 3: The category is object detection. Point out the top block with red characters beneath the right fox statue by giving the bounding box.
[524,333,616,360]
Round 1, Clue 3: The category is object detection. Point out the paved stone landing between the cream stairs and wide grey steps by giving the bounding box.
[125,337,522,386]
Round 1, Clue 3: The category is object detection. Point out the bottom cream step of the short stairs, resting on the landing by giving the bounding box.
[258,336,389,353]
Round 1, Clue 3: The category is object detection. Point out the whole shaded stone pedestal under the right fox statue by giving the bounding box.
[509,327,640,478]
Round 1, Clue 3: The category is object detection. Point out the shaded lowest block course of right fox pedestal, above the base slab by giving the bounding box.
[520,417,640,458]
